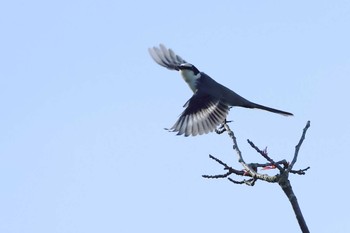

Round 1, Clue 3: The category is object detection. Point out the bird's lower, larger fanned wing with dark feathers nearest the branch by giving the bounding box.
[170,92,229,137]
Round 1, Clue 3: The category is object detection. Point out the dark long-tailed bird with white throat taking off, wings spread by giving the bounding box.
[148,44,293,137]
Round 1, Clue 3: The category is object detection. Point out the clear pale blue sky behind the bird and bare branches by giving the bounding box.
[0,0,350,233]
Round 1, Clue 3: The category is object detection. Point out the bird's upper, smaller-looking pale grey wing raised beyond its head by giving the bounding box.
[148,44,187,70]
